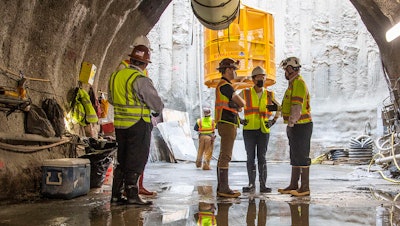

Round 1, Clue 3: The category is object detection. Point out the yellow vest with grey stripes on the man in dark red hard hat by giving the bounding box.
[109,68,150,129]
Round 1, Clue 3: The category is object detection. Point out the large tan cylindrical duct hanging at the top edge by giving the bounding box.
[191,0,240,30]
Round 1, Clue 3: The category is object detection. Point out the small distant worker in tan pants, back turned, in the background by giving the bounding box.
[194,107,215,170]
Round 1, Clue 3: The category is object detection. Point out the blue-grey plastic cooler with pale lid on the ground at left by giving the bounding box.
[41,158,90,199]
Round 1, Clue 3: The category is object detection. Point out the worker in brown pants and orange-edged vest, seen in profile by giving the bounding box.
[215,58,245,198]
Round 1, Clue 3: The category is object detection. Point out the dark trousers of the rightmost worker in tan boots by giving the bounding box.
[286,122,313,166]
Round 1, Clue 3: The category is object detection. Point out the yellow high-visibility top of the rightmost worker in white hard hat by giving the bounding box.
[282,75,312,124]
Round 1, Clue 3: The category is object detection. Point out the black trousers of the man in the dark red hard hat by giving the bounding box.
[115,119,153,184]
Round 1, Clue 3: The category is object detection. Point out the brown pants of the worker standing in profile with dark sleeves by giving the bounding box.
[218,122,237,169]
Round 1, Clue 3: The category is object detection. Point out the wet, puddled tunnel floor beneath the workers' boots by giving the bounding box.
[0,162,400,226]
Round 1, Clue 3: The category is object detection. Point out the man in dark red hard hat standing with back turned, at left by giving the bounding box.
[108,45,164,205]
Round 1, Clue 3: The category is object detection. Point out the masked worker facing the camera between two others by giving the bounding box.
[242,66,280,193]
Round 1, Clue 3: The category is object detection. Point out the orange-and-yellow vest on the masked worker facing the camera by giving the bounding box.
[243,87,271,133]
